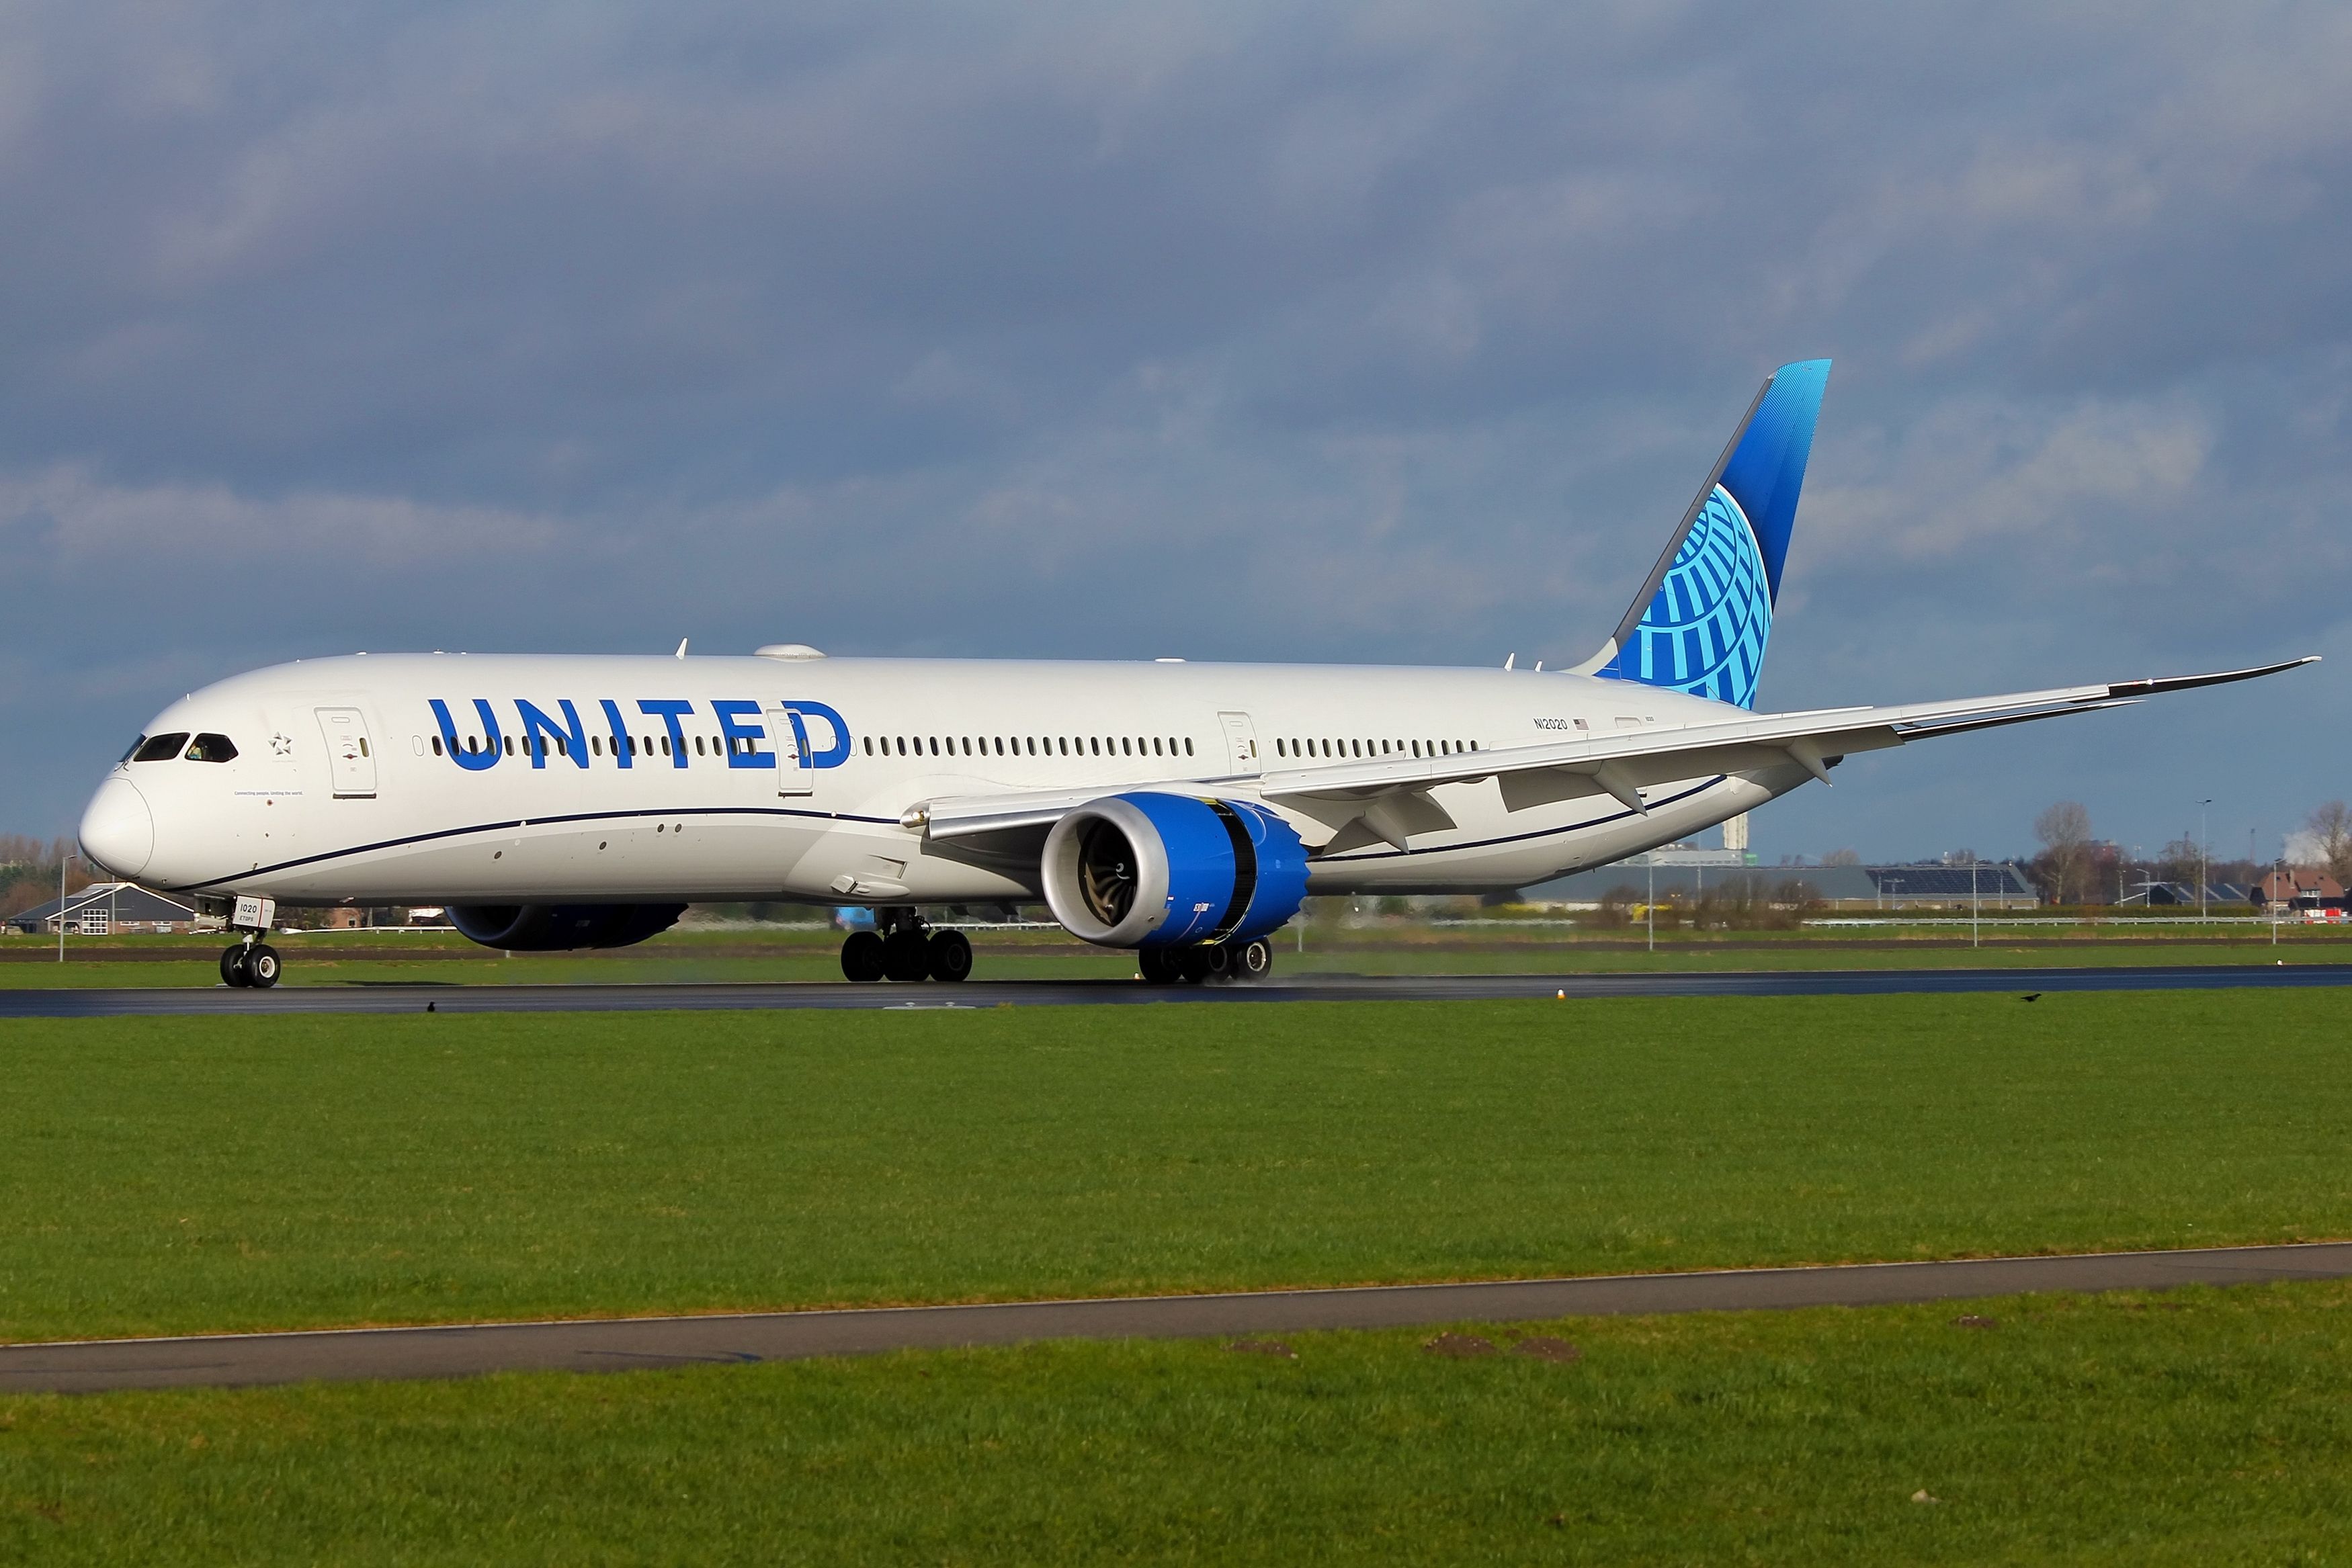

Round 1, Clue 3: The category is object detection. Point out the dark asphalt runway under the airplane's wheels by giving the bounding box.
[0,964,2352,1018]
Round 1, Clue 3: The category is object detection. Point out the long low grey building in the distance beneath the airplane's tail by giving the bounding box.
[1519,865,2042,912]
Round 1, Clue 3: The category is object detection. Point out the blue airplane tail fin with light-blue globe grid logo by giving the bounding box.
[1581,359,1830,707]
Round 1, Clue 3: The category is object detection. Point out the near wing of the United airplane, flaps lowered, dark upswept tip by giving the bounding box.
[903,656,2317,853]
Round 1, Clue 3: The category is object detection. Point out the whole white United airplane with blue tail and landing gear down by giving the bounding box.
[80,359,2314,988]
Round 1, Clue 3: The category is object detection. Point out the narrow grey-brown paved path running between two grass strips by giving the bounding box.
[0,1242,2352,1394]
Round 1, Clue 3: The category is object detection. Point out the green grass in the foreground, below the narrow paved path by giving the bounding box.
[0,1284,2352,1563]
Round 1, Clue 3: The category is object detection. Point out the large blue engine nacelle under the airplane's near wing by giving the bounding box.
[1044,790,1308,947]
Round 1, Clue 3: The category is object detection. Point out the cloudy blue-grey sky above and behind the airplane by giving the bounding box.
[0,0,2352,861]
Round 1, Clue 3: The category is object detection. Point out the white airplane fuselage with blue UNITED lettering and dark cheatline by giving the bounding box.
[85,654,1806,903]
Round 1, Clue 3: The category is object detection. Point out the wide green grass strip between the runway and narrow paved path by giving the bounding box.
[0,992,2352,1338]
